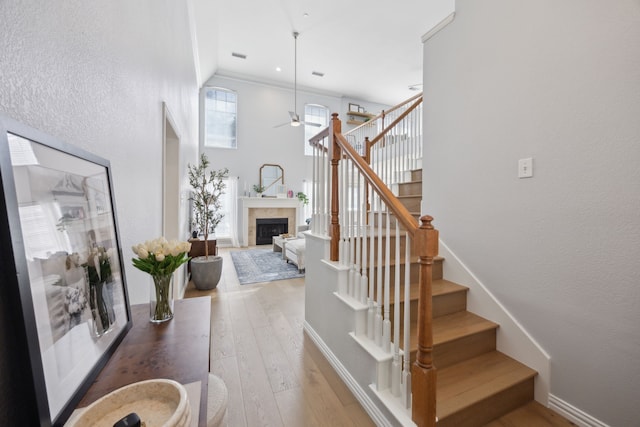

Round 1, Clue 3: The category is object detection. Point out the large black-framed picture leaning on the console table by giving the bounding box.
[0,115,132,426]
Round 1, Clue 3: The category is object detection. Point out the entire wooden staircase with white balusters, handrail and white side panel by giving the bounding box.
[305,98,572,427]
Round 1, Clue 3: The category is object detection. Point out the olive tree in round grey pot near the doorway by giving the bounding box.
[188,153,229,290]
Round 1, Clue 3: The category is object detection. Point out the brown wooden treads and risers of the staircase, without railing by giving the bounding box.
[392,170,544,427]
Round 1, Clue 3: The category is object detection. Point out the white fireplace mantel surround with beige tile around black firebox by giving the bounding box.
[240,197,300,246]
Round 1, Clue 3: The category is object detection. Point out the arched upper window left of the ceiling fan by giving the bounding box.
[204,87,237,148]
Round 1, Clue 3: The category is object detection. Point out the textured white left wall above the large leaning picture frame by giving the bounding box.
[0,0,198,304]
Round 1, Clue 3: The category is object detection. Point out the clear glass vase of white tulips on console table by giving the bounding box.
[132,237,191,323]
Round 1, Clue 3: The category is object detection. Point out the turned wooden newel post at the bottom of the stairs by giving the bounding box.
[411,215,438,427]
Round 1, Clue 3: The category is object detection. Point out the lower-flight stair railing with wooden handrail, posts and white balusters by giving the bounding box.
[310,114,438,426]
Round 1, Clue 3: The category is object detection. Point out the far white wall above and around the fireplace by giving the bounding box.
[200,76,386,242]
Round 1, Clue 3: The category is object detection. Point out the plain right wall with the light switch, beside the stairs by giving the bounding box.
[424,0,640,426]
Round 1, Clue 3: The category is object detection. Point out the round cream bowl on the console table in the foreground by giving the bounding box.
[65,379,191,427]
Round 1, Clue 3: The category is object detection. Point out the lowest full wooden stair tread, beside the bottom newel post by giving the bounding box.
[436,351,537,419]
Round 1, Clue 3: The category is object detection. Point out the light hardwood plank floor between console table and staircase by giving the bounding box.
[185,249,375,427]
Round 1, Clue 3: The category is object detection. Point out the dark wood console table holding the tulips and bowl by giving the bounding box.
[78,297,211,426]
